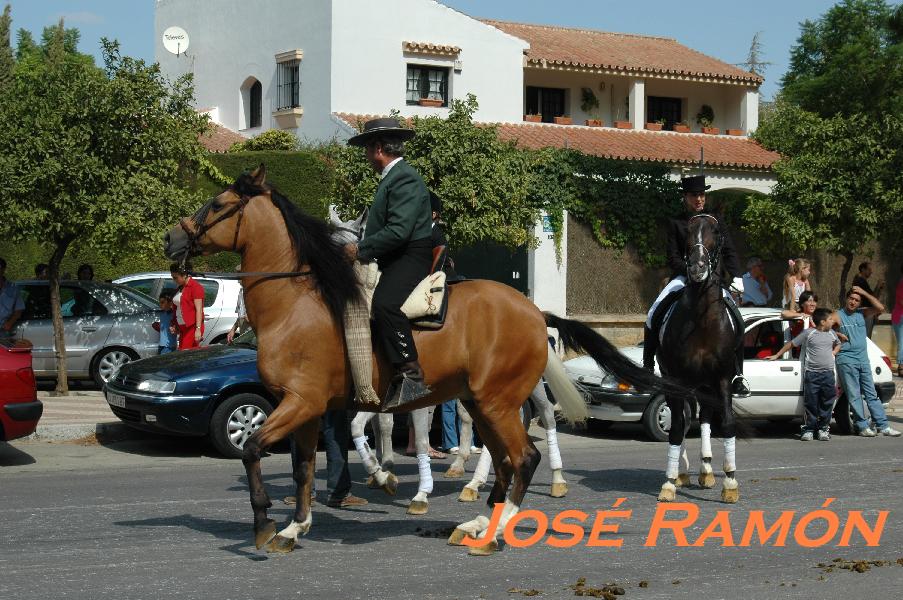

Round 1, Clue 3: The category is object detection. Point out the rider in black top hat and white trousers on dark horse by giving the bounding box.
[643,175,750,397]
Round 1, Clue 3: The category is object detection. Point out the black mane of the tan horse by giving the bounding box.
[232,173,361,325]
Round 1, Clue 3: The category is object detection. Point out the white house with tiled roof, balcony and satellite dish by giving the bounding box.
[155,0,777,313]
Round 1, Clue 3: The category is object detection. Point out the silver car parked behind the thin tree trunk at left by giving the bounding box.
[16,280,160,385]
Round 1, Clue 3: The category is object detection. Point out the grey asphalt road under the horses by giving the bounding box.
[0,416,903,600]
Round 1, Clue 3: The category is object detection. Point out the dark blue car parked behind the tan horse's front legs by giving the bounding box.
[104,331,276,458]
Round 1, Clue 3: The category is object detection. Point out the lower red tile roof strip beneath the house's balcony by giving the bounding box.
[336,113,781,171]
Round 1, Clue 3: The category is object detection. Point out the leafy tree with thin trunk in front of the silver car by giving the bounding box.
[0,32,207,393]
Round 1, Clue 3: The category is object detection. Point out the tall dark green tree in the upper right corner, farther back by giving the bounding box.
[781,0,903,118]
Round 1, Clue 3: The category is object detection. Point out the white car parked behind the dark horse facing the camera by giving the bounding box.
[564,308,894,441]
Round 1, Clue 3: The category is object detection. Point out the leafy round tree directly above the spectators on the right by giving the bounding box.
[744,100,903,298]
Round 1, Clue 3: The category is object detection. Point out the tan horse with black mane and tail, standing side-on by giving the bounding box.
[165,165,708,554]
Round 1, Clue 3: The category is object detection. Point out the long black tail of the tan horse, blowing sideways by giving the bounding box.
[543,313,717,406]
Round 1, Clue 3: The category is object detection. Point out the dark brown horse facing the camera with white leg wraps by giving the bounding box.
[658,214,742,503]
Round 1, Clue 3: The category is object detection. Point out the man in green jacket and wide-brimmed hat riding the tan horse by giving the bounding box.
[346,118,433,408]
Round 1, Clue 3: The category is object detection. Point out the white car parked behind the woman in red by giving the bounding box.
[113,272,241,345]
